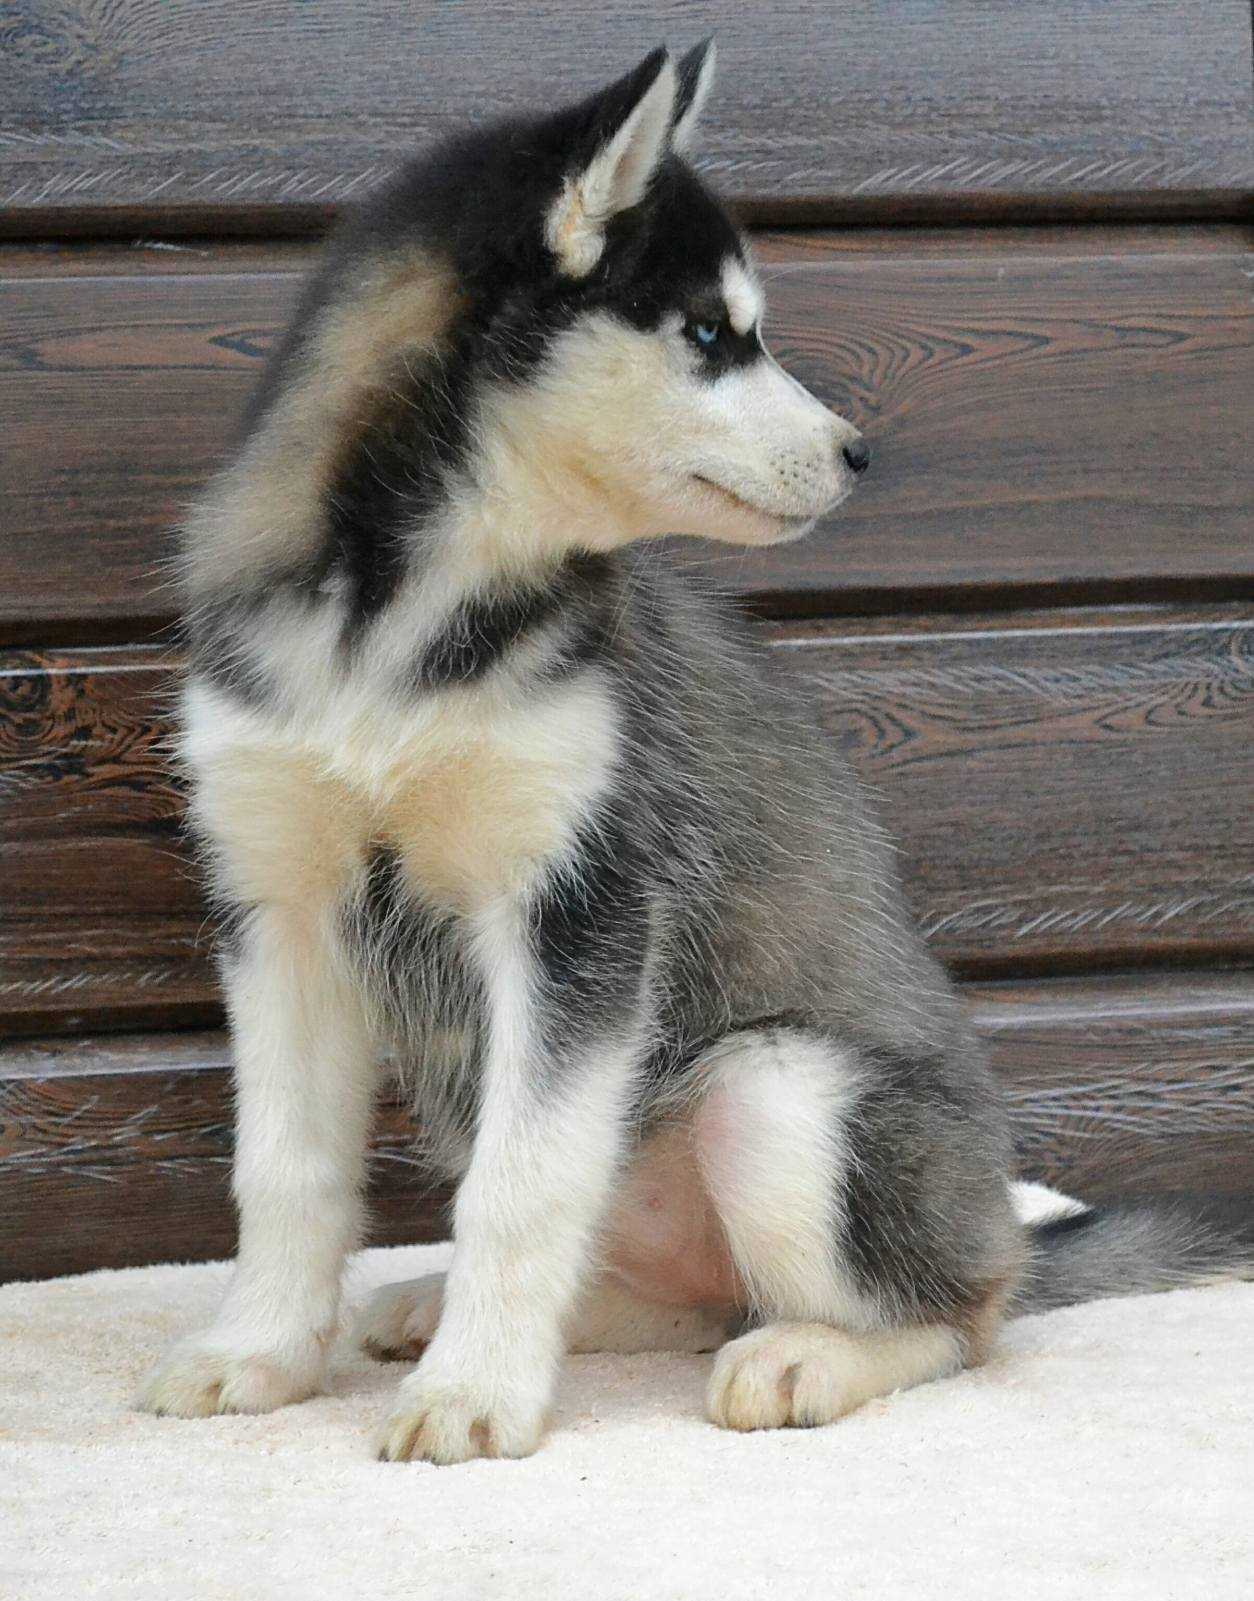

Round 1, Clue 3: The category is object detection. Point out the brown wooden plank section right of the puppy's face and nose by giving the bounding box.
[721,229,1254,612]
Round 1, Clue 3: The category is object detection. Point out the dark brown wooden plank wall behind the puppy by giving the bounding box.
[0,0,1254,1276]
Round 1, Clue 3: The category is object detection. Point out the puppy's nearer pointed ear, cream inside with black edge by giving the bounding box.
[545,50,677,279]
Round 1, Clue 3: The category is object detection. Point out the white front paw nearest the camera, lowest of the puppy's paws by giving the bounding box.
[380,1366,546,1463]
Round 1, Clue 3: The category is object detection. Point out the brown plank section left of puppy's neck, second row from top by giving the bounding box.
[0,272,296,639]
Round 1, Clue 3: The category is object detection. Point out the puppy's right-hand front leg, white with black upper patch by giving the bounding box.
[380,839,645,1462]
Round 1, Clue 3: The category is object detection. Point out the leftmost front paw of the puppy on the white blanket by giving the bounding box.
[136,1335,325,1417]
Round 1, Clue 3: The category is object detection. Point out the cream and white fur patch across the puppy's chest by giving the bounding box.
[183,672,618,913]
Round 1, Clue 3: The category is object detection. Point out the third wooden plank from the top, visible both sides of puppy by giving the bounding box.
[0,607,1254,1033]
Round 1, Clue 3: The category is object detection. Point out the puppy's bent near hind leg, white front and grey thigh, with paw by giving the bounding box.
[693,1029,1017,1430]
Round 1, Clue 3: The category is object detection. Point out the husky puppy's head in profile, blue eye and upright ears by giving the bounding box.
[464,43,866,544]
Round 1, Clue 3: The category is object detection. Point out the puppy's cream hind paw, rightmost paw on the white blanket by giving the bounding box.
[705,1322,865,1430]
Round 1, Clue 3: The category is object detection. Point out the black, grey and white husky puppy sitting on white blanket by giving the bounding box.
[143,46,1254,1462]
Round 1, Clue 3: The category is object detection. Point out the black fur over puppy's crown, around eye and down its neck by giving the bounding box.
[227,54,761,645]
